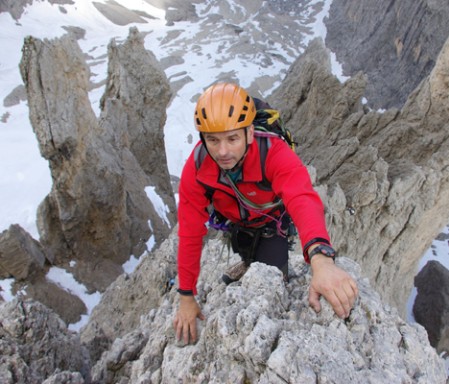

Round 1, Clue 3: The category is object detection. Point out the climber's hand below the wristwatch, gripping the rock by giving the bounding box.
[309,254,358,319]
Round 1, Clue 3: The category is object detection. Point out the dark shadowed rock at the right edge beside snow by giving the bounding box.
[413,260,449,353]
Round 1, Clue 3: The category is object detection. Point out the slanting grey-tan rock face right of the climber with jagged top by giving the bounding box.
[270,36,449,315]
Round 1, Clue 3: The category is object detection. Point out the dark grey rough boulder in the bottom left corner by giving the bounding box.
[0,300,89,384]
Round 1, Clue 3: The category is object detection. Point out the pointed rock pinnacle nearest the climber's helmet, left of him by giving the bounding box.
[101,28,176,242]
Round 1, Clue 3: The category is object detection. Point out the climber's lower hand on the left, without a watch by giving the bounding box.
[173,296,205,344]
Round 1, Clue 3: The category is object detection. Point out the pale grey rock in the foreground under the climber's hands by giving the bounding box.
[80,236,446,384]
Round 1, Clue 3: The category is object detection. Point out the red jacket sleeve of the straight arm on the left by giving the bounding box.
[178,148,209,295]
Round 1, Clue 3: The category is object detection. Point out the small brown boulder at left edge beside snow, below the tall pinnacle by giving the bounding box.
[0,224,46,280]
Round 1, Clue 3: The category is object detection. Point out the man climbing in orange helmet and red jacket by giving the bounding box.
[173,83,358,343]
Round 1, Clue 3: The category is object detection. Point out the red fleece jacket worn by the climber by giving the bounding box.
[178,138,329,294]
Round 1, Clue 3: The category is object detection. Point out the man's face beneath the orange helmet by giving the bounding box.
[203,125,254,170]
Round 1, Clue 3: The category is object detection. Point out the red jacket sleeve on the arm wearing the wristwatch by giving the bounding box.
[265,139,330,262]
